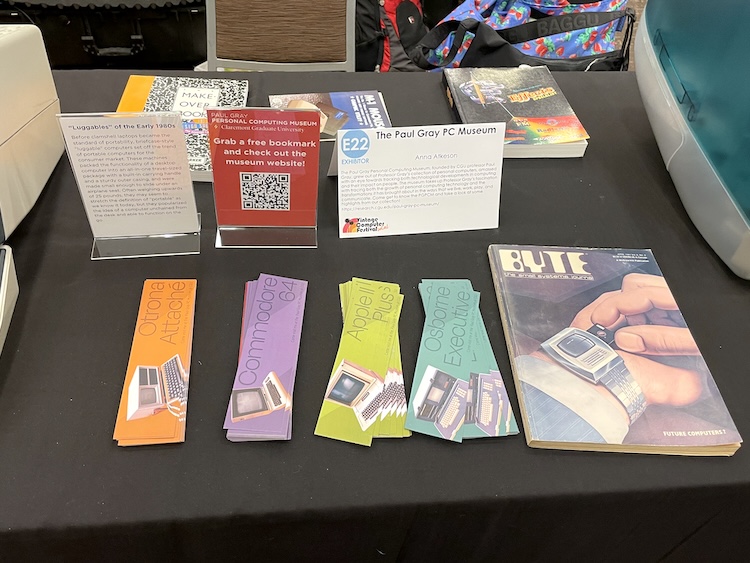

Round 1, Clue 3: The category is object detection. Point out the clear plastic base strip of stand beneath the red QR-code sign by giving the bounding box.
[216,226,318,248]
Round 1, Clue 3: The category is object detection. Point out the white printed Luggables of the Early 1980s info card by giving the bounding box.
[59,113,200,238]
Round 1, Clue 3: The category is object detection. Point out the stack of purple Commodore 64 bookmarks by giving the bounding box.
[224,274,307,441]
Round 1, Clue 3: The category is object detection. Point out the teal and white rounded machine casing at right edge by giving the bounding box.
[635,0,750,279]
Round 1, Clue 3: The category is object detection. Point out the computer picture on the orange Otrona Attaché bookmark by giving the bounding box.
[127,355,188,420]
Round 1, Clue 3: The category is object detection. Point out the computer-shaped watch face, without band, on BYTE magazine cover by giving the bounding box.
[542,327,622,383]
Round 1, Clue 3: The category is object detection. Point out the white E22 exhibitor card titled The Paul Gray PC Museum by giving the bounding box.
[336,123,505,238]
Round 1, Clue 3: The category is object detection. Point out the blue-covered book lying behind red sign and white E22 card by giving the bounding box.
[268,90,391,141]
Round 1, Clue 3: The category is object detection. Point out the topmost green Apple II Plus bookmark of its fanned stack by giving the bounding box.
[315,278,403,446]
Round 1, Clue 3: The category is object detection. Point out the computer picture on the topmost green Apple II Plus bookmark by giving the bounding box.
[325,360,383,430]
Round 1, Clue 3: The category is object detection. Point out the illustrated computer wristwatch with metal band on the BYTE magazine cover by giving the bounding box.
[542,325,646,424]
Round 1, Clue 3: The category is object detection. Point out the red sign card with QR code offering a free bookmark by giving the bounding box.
[207,108,320,227]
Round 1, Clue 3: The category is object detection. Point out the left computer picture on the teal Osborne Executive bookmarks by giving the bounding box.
[414,366,469,440]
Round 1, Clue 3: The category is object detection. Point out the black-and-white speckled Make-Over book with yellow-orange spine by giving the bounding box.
[117,75,248,182]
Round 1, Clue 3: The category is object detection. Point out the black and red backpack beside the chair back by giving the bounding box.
[355,0,427,72]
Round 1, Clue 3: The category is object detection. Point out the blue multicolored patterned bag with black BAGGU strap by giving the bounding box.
[417,0,634,70]
